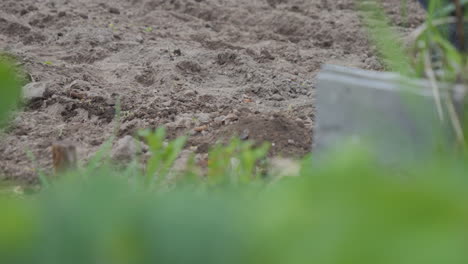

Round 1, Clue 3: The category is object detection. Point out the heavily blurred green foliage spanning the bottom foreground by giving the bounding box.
[0,149,468,264]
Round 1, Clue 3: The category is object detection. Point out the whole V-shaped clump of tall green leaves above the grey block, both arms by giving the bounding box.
[358,0,468,149]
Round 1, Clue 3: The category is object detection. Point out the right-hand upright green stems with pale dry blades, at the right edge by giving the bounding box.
[413,1,468,148]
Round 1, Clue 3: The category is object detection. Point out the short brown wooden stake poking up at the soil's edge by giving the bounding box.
[52,142,77,175]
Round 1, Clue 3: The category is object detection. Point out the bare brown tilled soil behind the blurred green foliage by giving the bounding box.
[0,0,423,181]
